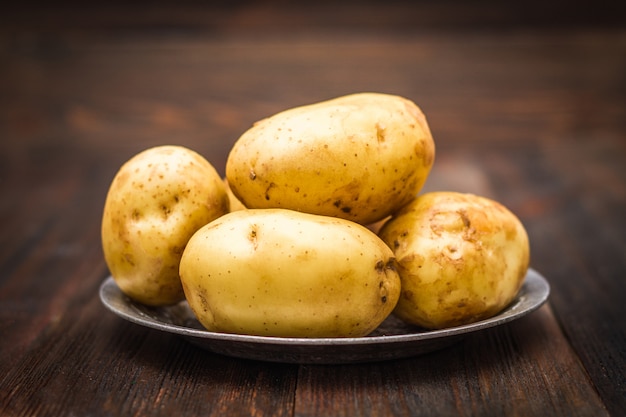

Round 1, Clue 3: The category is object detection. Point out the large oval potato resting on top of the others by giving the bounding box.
[226,93,435,224]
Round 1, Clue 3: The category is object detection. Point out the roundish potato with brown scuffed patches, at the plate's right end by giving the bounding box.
[379,192,530,329]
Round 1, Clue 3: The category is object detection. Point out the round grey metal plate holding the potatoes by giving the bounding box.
[100,269,550,364]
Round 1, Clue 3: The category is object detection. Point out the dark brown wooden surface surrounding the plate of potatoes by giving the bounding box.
[0,2,626,417]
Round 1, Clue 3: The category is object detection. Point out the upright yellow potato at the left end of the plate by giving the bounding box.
[101,146,228,306]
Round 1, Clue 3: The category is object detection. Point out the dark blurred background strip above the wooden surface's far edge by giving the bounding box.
[2,0,625,34]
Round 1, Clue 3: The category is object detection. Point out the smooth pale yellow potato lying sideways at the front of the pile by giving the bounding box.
[180,209,400,337]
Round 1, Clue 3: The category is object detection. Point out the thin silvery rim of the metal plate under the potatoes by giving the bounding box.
[99,268,550,347]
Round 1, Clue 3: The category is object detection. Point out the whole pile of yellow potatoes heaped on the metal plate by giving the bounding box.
[102,93,530,337]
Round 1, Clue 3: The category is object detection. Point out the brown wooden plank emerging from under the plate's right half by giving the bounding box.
[295,306,608,416]
